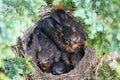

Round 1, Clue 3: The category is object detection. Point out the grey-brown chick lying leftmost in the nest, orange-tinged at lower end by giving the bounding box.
[35,30,61,72]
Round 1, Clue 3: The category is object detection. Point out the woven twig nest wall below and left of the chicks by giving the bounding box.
[11,27,98,80]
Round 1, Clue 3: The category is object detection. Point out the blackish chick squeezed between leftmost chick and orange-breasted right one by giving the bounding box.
[36,17,66,51]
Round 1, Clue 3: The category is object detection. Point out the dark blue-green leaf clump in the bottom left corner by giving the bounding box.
[3,58,34,80]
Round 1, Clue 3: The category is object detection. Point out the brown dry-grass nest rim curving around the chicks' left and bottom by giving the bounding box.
[13,6,98,80]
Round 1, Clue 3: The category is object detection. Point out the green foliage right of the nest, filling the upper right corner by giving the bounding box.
[73,0,120,54]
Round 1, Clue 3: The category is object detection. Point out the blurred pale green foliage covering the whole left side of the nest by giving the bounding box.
[0,0,46,80]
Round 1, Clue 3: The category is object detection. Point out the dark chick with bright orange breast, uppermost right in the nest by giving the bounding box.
[51,9,88,52]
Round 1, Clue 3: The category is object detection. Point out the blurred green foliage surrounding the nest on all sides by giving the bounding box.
[0,0,120,80]
